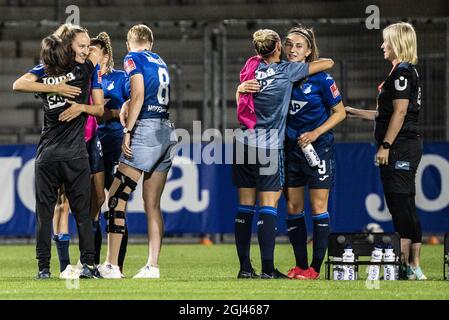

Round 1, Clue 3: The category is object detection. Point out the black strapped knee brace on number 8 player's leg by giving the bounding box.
[104,171,137,234]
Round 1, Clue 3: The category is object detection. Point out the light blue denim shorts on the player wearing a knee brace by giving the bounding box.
[119,119,177,172]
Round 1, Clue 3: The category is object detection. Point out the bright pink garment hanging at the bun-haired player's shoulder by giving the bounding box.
[237,56,262,129]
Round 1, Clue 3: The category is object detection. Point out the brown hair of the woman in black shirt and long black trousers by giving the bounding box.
[40,34,75,76]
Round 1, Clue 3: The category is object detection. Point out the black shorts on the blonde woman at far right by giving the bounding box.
[380,139,422,194]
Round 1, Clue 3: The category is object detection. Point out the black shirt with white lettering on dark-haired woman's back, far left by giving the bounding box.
[36,60,95,161]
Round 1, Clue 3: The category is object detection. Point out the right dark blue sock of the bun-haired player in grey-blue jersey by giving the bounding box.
[257,206,277,273]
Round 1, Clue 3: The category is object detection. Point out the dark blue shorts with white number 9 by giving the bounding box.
[285,139,335,189]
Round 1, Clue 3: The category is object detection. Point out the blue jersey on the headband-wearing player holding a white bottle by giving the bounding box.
[287,72,341,142]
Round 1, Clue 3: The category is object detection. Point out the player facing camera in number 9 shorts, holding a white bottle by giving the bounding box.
[284,27,346,279]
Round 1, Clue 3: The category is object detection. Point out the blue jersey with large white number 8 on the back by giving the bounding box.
[124,51,170,119]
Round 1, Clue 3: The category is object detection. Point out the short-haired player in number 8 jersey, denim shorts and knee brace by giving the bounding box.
[100,24,176,279]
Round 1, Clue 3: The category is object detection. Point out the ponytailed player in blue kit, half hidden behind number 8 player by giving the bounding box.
[90,32,129,273]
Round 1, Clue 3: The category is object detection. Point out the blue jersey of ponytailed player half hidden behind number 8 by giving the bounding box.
[98,69,129,139]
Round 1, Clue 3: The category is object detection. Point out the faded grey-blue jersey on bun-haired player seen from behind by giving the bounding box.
[240,61,309,149]
